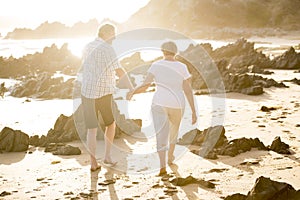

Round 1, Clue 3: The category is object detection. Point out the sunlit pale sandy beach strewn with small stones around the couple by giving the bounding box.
[0,70,300,199]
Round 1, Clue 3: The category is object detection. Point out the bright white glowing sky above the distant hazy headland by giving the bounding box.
[0,0,150,32]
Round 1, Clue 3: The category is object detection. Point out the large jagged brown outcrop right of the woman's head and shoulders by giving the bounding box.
[177,38,286,95]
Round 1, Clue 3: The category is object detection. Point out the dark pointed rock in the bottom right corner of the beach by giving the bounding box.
[225,176,300,200]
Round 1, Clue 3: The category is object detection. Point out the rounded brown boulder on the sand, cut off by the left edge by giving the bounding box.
[0,127,29,152]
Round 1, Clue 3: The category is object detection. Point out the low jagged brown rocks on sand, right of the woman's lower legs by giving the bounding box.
[178,126,291,159]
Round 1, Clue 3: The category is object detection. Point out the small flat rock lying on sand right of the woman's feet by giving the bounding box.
[170,176,215,188]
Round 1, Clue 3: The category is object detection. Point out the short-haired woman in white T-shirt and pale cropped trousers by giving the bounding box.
[127,41,197,176]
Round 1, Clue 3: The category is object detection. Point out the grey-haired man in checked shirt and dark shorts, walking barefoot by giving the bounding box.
[81,24,133,171]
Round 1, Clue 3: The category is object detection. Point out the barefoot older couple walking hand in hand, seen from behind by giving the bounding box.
[81,24,197,175]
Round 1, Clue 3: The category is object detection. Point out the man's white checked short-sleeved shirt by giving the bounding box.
[81,38,121,99]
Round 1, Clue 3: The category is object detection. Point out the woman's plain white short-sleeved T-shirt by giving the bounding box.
[148,60,191,109]
